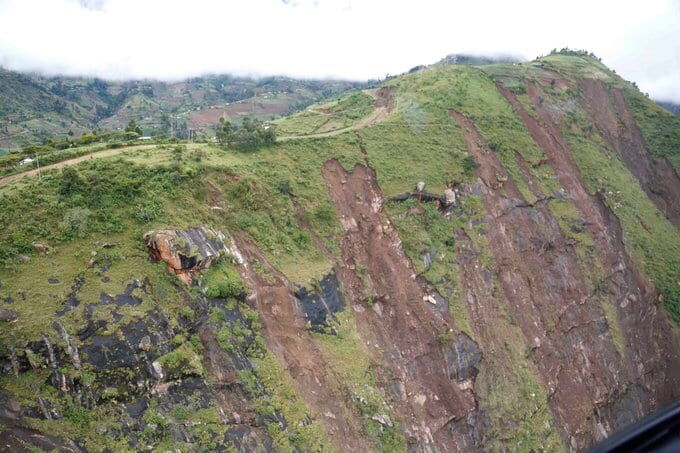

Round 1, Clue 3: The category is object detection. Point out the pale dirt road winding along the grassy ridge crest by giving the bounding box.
[0,88,394,186]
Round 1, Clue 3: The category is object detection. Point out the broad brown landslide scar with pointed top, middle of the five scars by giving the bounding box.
[452,112,620,448]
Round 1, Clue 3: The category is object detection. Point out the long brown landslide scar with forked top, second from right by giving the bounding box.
[497,85,680,448]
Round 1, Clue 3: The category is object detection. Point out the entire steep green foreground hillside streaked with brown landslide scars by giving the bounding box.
[0,53,680,452]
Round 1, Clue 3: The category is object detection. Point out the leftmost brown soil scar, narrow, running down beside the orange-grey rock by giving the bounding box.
[230,236,370,451]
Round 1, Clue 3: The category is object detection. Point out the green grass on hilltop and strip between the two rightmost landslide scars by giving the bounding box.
[484,55,680,323]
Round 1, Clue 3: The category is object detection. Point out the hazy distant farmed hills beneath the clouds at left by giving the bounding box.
[0,68,363,148]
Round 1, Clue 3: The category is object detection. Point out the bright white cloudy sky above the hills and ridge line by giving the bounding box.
[0,0,680,102]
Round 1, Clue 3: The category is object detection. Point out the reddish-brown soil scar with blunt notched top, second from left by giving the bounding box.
[323,160,476,451]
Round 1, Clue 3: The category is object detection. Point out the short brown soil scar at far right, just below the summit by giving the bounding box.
[579,79,680,227]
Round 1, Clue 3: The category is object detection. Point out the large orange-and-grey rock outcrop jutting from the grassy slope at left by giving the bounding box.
[144,227,239,285]
